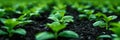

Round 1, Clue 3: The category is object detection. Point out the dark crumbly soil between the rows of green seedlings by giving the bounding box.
[0,6,119,40]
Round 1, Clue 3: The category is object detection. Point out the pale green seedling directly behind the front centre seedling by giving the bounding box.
[48,11,73,23]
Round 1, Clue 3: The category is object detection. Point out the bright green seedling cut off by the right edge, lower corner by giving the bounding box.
[98,22,120,40]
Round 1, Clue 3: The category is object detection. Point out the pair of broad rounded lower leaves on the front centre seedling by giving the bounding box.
[35,30,79,40]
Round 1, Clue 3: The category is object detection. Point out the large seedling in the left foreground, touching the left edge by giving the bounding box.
[0,18,26,37]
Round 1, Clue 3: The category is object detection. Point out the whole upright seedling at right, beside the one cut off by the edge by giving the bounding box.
[93,13,117,30]
